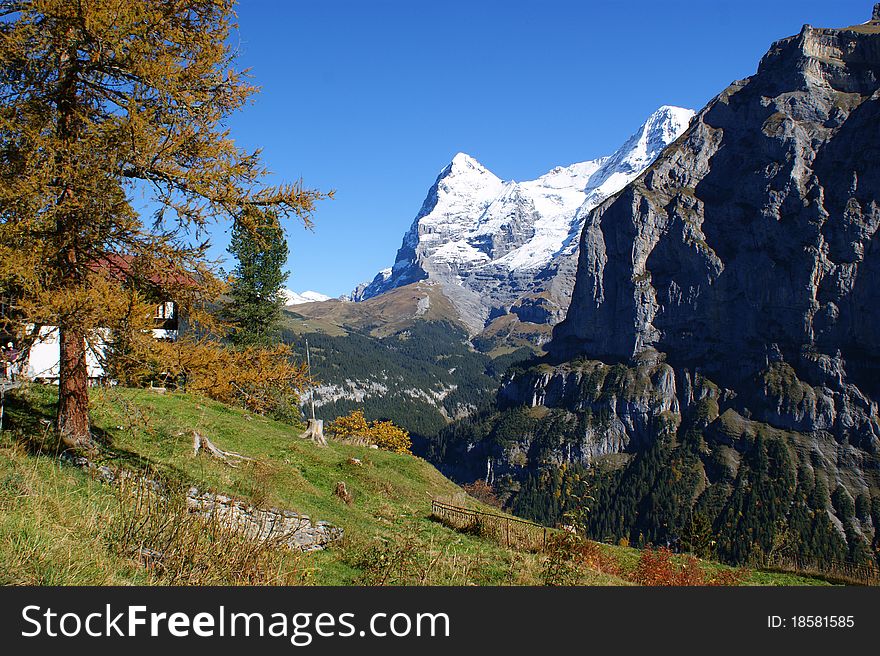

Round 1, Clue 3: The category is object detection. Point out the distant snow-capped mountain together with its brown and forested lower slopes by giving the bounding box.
[284,107,694,444]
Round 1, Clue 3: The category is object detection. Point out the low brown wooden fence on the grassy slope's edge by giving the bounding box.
[431,500,548,551]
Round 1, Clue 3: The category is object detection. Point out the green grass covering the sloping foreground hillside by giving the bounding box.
[0,387,832,585]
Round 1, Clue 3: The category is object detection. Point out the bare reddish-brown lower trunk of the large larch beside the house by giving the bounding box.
[58,327,94,449]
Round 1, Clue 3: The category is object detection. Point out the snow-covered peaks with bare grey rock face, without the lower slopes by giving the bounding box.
[353,107,693,333]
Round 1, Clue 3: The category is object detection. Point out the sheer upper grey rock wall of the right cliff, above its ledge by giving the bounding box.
[551,19,880,450]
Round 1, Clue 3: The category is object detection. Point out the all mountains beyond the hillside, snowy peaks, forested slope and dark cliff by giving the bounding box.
[288,6,880,563]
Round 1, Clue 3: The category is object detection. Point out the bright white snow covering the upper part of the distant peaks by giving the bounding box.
[356,105,694,298]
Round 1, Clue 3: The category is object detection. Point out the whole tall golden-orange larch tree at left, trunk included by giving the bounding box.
[0,0,326,447]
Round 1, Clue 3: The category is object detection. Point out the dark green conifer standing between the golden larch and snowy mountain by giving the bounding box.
[225,213,288,346]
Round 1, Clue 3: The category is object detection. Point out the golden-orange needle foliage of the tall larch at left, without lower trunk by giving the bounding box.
[0,0,332,290]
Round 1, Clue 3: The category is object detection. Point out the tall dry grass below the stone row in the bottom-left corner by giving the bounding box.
[0,444,311,585]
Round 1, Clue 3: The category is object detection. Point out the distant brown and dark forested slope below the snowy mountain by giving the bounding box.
[282,312,531,444]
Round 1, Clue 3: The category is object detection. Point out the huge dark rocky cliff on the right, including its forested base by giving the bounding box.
[438,10,880,561]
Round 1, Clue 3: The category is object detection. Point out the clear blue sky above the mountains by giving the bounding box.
[213,0,872,296]
